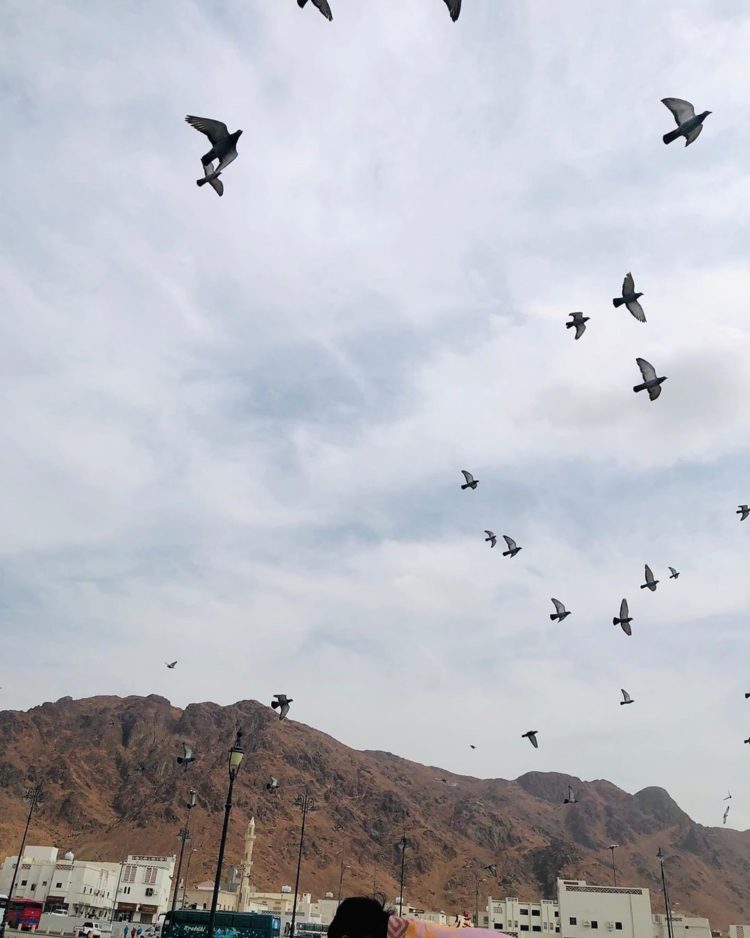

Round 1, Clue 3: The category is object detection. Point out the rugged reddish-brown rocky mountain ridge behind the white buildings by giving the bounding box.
[0,696,750,929]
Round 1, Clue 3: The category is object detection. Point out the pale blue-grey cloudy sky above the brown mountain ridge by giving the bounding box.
[0,0,750,829]
